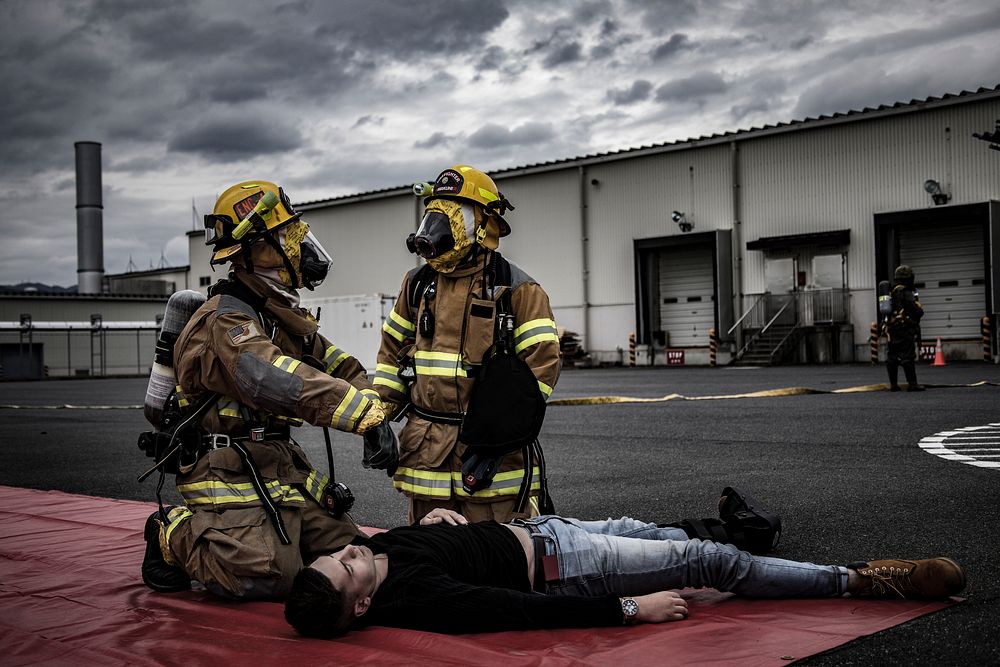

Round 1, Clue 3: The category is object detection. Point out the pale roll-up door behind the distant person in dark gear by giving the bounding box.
[899,224,986,341]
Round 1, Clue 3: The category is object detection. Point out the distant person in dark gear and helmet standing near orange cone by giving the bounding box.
[882,264,924,391]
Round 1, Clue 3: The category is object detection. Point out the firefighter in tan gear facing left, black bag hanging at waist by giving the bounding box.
[374,165,560,522]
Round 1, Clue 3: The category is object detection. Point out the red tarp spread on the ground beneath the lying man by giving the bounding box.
[0,486,960,667]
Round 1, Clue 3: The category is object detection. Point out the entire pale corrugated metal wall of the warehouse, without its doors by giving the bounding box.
[172,92,1000,358]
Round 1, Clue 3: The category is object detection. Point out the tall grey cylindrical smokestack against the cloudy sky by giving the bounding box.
[73,141,104,294]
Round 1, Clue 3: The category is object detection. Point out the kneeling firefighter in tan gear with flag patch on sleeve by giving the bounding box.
[142,181,397,599]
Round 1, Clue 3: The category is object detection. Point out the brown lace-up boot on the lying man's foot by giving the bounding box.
[847,558,965,600]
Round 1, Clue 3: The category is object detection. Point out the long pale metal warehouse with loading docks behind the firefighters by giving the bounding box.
[190,86,1000,364]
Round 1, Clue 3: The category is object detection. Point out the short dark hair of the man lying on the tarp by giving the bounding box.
[285,567,353,639]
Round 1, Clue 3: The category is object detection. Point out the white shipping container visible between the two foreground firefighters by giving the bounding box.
[301,294,396,375]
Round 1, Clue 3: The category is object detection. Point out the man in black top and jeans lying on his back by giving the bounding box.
[285,509,965,638]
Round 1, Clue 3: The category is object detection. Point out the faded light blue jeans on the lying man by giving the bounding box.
[512,516,847,598]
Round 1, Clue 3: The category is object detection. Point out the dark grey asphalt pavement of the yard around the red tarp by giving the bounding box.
[0,362,1000,665]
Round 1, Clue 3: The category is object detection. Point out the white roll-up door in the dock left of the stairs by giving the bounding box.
[659,245,715,347]
